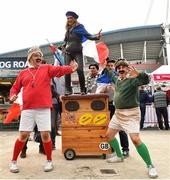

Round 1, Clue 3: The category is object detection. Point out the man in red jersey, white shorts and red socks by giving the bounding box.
[10,47,78,173]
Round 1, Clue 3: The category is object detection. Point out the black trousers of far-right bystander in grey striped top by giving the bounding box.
[156,107,169,130]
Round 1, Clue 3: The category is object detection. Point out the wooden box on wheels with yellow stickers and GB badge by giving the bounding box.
[61,94,111,160]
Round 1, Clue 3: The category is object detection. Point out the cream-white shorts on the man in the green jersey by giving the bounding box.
[109,107,140,133]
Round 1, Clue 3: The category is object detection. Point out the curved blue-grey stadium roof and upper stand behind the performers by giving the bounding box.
[0,24,166,64]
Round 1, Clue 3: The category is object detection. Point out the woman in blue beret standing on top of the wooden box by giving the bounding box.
[60,11,102,95]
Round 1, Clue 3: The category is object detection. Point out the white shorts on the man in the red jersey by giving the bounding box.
[19,108,51,132]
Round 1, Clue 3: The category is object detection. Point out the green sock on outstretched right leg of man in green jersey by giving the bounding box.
[136,143,152,166]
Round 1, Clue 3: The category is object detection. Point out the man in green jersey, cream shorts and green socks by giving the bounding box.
[106,59,158,178]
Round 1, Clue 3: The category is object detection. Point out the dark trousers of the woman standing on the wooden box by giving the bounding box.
[64,52,85,92]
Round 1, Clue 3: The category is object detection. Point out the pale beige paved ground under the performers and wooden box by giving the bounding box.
[0,130,170,179]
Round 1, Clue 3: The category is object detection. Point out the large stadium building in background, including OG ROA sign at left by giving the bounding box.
[0,24,168,102]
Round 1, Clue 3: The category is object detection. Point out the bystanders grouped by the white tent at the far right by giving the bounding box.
[139,85,170,130]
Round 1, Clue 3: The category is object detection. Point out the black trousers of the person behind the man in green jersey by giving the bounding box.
[109,102,129,151]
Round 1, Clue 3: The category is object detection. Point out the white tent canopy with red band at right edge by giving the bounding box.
[152,65,170,81]
